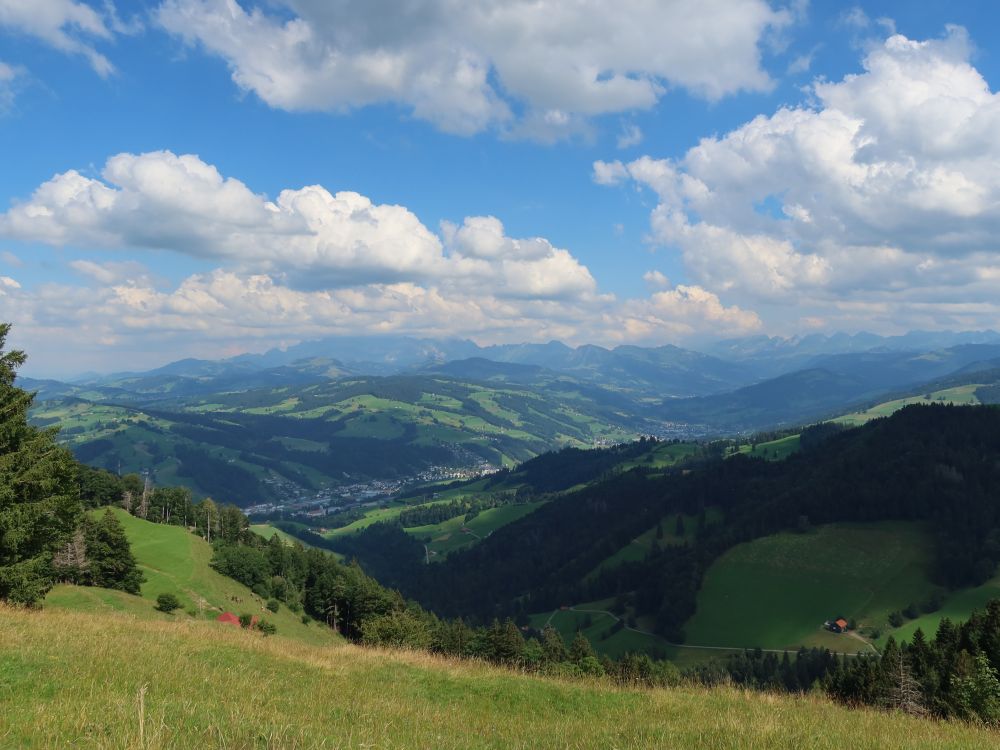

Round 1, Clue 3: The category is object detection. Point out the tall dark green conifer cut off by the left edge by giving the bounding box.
[0,323,82,605]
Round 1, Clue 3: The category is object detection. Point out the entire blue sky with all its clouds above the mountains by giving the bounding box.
[0,0,1000,377]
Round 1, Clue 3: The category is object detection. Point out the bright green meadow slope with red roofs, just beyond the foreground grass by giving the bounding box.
[44,508,339,645]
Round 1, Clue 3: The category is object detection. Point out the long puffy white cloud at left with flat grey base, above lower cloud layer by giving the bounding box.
[0,151,596,298]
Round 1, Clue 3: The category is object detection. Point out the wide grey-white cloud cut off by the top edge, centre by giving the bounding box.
[157,0,792,140]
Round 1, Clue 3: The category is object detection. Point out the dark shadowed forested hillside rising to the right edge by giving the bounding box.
[361,406,1000,638]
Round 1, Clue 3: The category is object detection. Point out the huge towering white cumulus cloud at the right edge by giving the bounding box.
[593,27,1000,327]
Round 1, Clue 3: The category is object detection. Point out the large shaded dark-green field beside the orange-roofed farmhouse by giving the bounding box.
[685,522,934,652]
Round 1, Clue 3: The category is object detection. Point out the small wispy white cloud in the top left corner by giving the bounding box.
[0,0,127,76]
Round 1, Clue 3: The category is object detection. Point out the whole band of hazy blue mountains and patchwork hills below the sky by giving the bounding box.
[19,331,1000,500]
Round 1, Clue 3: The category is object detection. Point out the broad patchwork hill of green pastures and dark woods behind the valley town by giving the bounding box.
[32,376,641,506]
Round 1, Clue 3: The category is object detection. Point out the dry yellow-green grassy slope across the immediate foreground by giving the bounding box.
[0,607,996,750]
